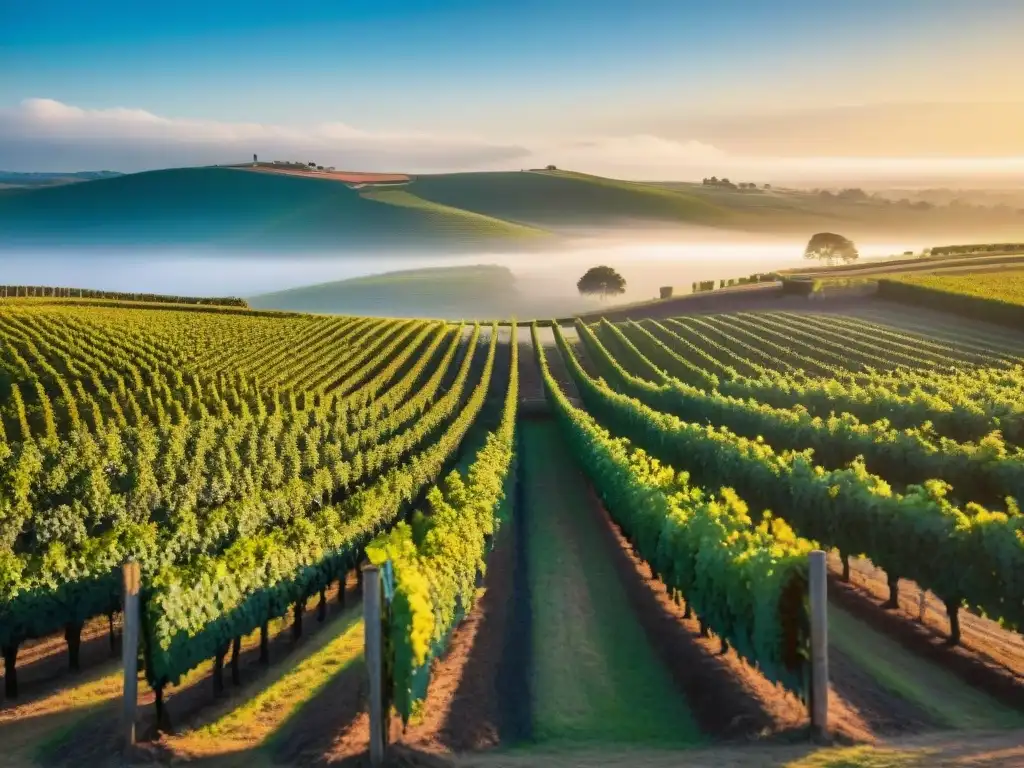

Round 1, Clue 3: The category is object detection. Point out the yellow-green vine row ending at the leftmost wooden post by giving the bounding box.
[143,321,498,686]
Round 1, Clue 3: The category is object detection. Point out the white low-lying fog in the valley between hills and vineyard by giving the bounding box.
[0,236,924,312]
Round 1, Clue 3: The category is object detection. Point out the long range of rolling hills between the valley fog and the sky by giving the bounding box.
[0,167,1024,254]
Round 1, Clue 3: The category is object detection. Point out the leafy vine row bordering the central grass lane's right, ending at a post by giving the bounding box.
[534,328,813,693]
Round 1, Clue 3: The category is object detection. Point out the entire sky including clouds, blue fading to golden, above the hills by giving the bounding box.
[0,0,1024,180]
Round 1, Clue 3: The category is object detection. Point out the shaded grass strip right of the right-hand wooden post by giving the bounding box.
[828,605,1024,730]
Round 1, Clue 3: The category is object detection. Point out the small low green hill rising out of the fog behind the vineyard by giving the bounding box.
[249,264,592,319]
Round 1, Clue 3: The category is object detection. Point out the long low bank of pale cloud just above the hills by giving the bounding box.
[0,98,1024,183]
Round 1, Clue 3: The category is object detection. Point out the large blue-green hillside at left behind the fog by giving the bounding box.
[0,168,557,252]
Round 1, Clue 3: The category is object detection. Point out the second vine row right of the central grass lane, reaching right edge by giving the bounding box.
[556,330,1024,628]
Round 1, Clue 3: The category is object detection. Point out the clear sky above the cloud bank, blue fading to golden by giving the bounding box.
[0,0,1024,175]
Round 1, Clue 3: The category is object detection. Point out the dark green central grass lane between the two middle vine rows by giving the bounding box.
[523,423,703,749]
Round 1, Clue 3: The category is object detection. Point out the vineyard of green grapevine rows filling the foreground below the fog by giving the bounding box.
[0,297,1024,765]
